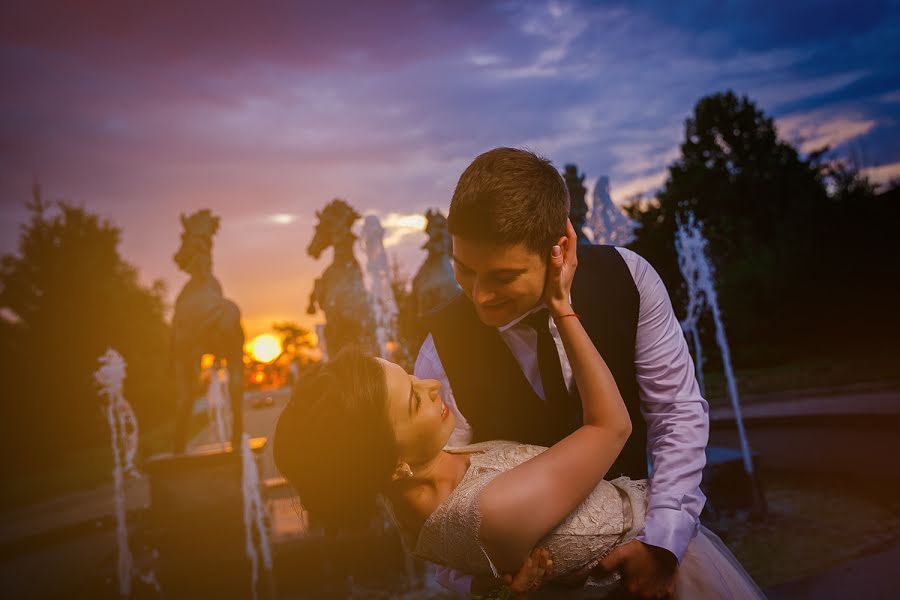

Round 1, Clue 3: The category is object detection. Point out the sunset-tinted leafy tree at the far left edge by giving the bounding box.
[0,184,173,467]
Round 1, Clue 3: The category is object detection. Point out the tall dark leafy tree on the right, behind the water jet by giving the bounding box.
[629,92,896,359]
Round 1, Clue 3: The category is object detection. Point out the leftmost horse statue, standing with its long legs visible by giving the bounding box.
[172,209,244,453]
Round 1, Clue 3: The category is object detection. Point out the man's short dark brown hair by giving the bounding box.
[447,148,569,258]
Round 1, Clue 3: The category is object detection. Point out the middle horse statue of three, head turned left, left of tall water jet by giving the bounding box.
[306,198,375,356]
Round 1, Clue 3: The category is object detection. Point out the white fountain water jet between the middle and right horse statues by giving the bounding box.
[360,215,398,360]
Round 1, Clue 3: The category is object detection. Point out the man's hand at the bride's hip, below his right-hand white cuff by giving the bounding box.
[593,540,678,598]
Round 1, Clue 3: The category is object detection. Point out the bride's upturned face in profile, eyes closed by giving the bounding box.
[376,358,456,469]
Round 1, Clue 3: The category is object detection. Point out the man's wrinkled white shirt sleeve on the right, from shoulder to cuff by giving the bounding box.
[620,250,709,562]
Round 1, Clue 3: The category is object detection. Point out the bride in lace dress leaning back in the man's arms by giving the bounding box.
[274,229,763,599]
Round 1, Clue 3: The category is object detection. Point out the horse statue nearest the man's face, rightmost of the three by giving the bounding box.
[412,210,460,322]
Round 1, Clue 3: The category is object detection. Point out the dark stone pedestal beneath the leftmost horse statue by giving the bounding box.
[146,438,272,600]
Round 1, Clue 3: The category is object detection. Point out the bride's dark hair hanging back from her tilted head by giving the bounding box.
[272,349,397,531]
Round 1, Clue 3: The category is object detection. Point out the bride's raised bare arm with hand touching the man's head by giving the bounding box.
[479,223,631,572]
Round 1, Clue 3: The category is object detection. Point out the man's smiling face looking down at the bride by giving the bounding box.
[452,235,549,327]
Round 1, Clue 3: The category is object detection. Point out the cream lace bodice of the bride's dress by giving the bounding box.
[414,442,648,576]
